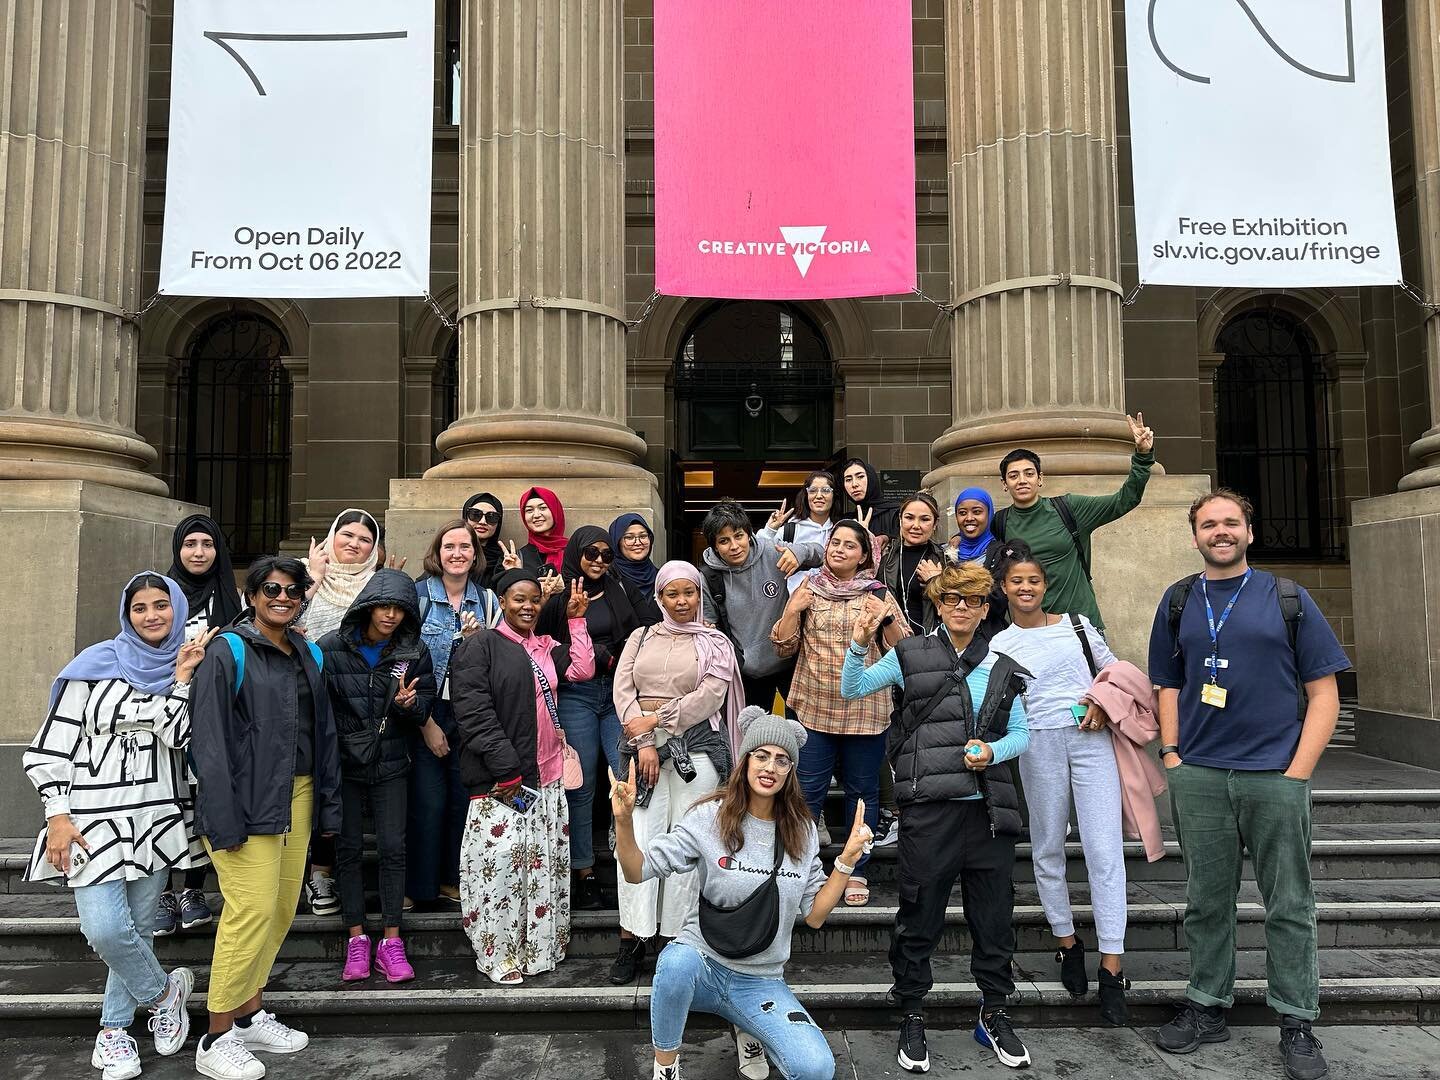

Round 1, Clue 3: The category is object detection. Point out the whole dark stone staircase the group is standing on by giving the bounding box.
[0,747,1440,1034]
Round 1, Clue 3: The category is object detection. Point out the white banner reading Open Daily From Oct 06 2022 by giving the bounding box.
[160,0,435,297]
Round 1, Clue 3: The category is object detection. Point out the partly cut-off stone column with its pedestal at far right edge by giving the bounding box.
[1349,0,1440,769]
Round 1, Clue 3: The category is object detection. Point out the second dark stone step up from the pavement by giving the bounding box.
[0,878,1440,961]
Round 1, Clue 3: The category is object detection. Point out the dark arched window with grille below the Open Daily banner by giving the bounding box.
[171,308,291,566]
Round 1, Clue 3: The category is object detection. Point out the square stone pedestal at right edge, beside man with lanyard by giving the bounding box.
[1349,487,1440,769]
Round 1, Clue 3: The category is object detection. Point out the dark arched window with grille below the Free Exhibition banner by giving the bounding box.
[1215,308,1345,559]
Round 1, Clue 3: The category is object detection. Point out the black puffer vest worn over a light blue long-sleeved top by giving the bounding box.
[886,631,1030,837]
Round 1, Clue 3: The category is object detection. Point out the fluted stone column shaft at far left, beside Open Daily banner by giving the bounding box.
[0,0,166,495]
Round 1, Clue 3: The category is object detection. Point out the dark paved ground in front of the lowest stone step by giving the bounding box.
[11,1025,1440,1080]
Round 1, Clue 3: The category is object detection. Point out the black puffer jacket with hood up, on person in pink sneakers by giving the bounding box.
[320,570,435,783]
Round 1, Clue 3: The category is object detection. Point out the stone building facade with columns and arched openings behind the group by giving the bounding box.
[0,0,1440,829]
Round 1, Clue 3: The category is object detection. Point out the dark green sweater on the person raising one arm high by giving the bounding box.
[1005,452,1155,629]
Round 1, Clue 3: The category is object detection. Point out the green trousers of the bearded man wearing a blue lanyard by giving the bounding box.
[1168,765,1320,1020]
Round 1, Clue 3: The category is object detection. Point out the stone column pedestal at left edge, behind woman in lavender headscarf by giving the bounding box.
[0,480,204,837]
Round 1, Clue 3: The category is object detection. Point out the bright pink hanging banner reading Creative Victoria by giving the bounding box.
[655,0,916,300]
